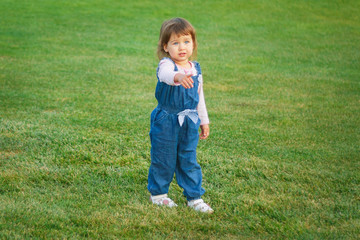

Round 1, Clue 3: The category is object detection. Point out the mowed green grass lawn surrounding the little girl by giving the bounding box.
[0,0,360,239]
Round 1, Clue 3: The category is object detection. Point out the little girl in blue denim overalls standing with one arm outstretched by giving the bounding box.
[148,18,214,213]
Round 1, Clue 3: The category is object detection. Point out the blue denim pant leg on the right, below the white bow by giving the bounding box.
[175,117,205,201]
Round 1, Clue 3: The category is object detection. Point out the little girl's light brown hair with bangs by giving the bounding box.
[157,18,197,60]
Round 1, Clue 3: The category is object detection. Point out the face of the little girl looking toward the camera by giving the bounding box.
[164,33,194,66]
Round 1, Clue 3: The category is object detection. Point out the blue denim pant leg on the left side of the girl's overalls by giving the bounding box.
[148,111,177,196]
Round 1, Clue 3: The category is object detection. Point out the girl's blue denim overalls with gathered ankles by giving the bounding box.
[148,58,205,201]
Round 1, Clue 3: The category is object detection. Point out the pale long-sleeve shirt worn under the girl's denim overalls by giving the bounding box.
[158,58,210,125]
